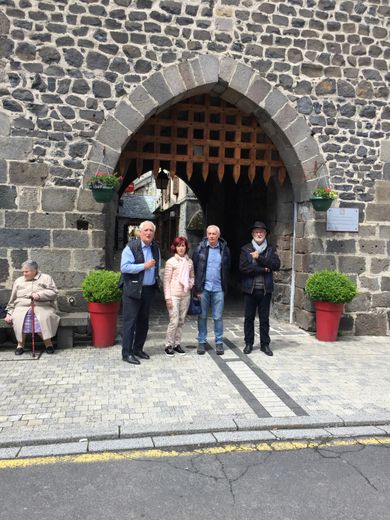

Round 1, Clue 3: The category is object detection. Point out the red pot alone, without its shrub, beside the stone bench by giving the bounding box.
[88,302,120,347]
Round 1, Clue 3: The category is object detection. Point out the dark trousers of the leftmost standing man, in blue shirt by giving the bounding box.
[122,285,155,357]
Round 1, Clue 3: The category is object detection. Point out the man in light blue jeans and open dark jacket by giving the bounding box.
[192,225,231,355]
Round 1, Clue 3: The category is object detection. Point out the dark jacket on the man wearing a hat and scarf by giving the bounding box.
[239,242,280,294]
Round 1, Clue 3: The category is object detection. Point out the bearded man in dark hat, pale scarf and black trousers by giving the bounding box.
[239,221,280,356]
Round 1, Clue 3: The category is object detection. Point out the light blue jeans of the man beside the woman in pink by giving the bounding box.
[198,289,224,345]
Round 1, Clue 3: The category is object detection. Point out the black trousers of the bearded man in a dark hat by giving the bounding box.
[244,291,271,347]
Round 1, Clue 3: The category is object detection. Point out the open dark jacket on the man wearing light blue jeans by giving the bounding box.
[192,238,231,294]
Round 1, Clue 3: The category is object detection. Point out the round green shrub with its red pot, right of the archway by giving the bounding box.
[305,270,357,341]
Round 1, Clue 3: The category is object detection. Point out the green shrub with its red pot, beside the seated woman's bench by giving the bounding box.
[81,269,122,347]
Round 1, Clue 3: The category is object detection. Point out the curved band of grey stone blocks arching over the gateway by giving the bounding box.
[84,55,327,197]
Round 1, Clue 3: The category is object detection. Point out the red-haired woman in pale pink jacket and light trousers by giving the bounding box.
[164,237,194,357]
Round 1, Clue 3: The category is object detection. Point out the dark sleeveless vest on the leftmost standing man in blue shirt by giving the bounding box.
[119,238,160,299]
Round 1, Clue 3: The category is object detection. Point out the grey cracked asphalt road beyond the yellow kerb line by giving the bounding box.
[0,442,390,520]
